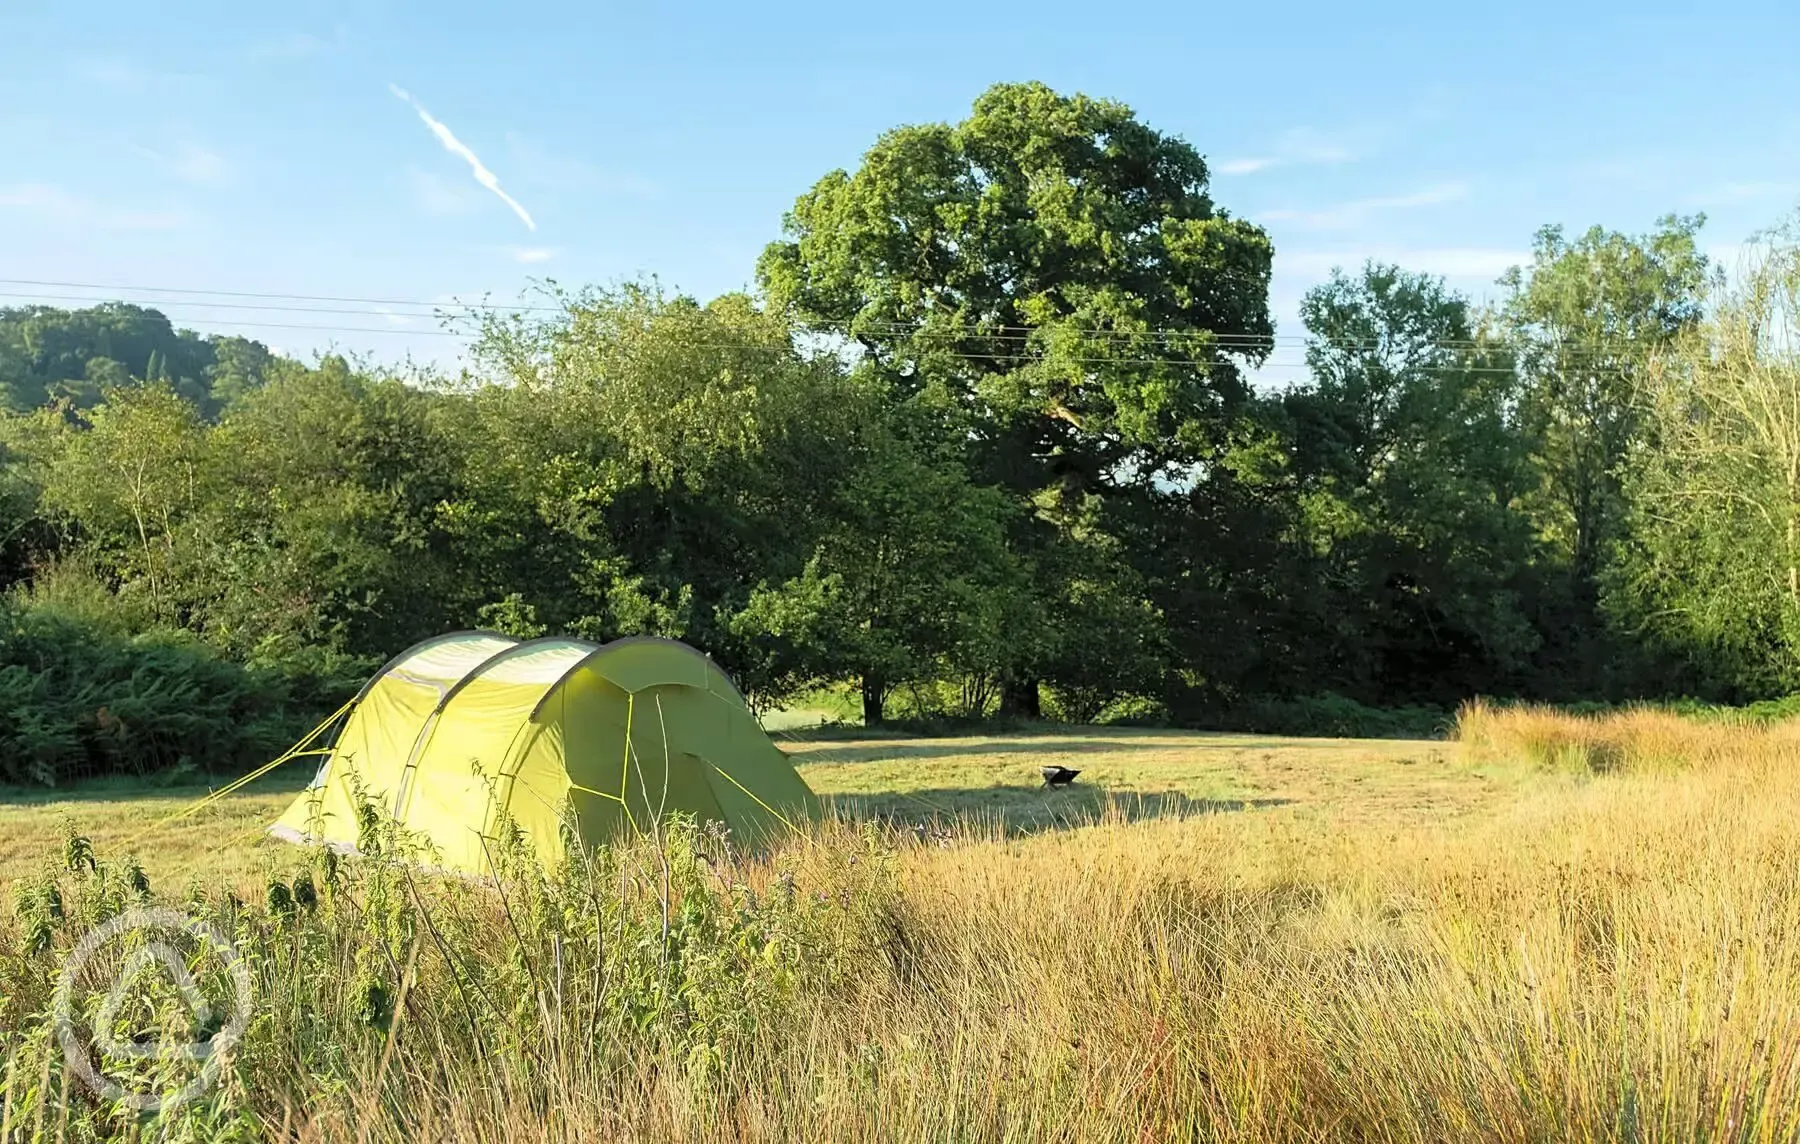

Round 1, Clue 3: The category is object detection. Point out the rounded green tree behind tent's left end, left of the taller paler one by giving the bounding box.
[196,358,479,662]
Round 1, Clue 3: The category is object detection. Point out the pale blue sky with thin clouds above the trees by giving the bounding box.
[0,0,1800,378]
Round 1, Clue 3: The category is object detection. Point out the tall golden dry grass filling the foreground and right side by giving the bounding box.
[10,712,1800,1142]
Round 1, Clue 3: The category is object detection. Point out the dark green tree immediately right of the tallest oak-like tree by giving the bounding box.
[1282,263,1537,702]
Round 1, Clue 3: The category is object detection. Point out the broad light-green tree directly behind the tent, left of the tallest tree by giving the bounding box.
[460,288,868,666]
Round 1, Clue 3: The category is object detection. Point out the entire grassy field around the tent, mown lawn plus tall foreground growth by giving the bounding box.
[0,709,1800,1144]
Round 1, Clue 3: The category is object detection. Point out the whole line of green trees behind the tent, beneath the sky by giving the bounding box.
[0,85,1800,772]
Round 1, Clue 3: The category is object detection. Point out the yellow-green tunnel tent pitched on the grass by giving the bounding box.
[270,631,819,874]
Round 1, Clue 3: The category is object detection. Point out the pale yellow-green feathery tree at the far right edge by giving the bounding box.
[1606,221,1800,698]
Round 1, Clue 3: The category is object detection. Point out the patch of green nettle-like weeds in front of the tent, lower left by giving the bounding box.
[0,797,898,1140]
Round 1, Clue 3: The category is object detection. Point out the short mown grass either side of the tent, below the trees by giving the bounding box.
[0,727,1468,885]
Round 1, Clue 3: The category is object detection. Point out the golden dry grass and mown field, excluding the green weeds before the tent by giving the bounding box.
[0,707,1800,1142]
